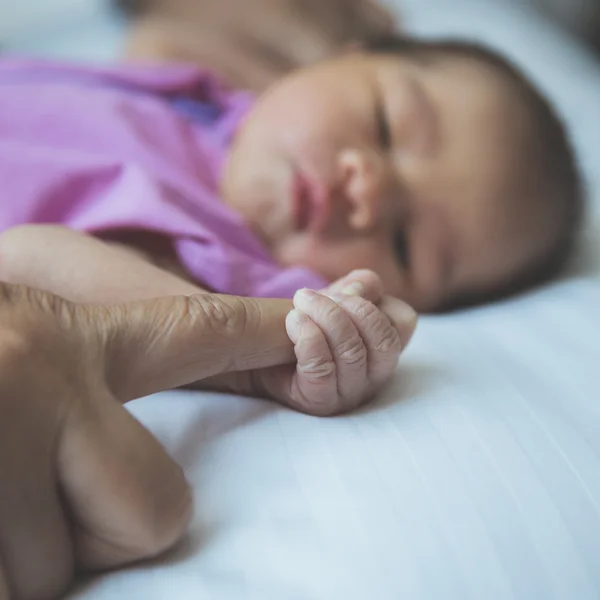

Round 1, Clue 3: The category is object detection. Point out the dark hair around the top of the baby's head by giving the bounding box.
[364,36,585,310]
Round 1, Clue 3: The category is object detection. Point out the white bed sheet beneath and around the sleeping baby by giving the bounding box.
[4,0,600,600]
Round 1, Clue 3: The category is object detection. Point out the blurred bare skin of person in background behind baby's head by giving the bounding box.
[126,0,395,91]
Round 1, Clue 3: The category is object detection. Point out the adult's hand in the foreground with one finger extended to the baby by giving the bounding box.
[0,284,293,600]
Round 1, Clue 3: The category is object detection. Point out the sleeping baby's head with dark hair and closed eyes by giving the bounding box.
[223,38,583,311]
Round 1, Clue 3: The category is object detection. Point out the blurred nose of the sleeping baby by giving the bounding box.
[339,149,385,231]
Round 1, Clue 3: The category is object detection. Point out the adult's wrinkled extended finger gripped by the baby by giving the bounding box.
[86,294,295,402]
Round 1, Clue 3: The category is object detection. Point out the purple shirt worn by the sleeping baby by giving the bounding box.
[0,60,325,297]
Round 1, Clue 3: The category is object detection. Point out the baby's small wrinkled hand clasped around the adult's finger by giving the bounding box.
[256,271,417,416]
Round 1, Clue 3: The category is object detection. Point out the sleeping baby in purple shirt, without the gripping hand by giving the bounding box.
[0,37,583,412]
